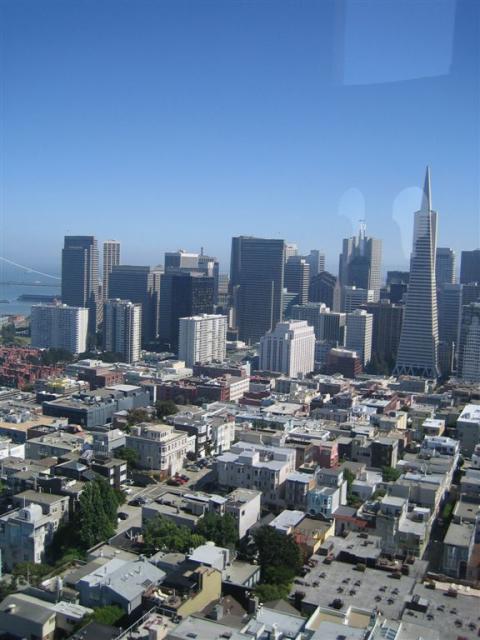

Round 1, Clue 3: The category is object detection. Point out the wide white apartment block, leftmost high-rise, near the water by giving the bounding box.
[30,304,88,354]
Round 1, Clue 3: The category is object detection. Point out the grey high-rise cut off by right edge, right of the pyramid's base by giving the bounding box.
[458,302,480,383]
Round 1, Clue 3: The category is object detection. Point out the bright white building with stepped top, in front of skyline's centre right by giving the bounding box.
[260,320,315,378]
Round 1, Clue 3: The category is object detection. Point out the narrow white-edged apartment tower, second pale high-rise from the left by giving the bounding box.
[103,299,142,363]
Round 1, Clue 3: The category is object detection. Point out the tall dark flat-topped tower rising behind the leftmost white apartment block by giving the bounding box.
[62,236,102,342]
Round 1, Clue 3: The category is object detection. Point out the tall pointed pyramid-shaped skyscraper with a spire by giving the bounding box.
[394,167,439,378]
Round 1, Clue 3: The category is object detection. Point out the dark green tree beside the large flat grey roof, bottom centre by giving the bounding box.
[254,525,303,583]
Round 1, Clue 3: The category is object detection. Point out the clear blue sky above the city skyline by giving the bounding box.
[0,0,480,270]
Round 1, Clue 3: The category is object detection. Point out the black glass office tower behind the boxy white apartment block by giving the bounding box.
[160,269,214,351]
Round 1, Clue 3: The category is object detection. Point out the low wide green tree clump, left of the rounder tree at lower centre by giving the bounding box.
[143,515,205,553]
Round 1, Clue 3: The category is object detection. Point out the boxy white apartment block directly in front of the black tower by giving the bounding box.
[178,313,228,367]
